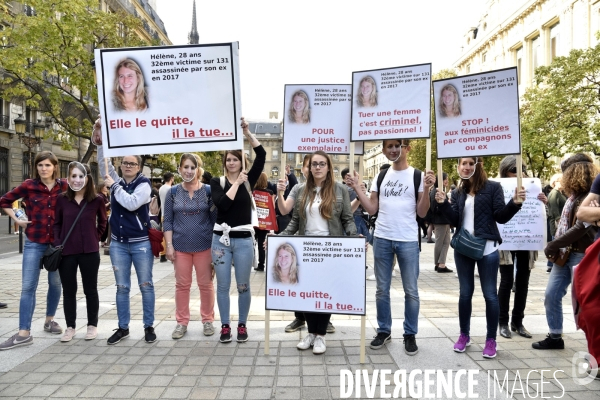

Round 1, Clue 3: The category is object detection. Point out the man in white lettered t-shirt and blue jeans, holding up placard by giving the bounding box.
[349,139,435,355]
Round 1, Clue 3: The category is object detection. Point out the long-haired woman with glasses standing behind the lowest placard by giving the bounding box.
[280,151,357,354]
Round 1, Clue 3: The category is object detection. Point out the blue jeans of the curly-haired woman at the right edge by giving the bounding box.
[544,253,584,333]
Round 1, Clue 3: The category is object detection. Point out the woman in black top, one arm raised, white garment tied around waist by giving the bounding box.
[210,118,267,343]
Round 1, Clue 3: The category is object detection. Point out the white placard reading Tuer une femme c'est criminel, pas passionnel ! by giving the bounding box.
[351,64,431,141]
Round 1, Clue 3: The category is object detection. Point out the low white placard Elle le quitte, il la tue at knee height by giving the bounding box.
[265,236,366,315]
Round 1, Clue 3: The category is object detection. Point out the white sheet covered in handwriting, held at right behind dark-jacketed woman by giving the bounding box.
[494,177,547,251]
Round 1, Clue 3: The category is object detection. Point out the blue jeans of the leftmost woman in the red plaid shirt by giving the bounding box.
[19,237,62,331]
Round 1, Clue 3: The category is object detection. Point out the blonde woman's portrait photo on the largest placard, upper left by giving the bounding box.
[112,58,148,111]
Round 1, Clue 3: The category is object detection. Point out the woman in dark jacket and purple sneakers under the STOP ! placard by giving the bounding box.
[435,157,525,358]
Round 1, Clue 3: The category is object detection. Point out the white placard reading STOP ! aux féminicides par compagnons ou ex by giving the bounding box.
[433,67,521,159]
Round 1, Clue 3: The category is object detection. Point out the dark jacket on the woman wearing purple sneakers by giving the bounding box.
[439,181,522,243]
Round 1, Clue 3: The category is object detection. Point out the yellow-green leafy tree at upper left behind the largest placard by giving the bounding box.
[0,0,145,162]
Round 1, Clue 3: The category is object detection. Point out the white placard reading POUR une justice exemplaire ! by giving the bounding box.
[283,85,363,155]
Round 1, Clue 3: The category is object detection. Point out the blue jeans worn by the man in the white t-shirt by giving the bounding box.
[373,237,420,336]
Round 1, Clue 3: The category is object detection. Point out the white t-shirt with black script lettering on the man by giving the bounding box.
[371,167,424,242]
